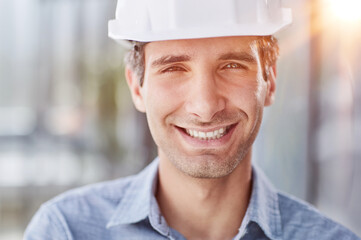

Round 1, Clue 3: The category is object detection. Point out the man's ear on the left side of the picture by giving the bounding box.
[125,65,145,112]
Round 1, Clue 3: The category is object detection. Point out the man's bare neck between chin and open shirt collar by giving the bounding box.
[156,151,252,239]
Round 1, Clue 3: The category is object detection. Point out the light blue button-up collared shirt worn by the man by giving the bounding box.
[24,159,360,240]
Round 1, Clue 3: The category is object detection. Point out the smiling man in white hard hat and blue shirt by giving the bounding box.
[25,0,359,240]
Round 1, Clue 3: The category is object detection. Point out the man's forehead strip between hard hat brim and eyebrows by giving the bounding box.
[144,36,257,63]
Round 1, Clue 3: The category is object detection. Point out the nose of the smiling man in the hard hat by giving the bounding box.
[186,72,226,122]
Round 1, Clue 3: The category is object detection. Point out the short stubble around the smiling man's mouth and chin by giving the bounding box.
[159,110,262,178]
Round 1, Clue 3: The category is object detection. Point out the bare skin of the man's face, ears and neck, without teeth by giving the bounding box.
[126,37,275,239]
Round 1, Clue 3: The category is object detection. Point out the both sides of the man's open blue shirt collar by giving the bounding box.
[107,158,282,240]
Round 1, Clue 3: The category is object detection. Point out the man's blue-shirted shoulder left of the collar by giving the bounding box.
[24,176,134,240]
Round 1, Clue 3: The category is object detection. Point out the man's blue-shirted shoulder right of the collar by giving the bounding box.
[278,193,360,240]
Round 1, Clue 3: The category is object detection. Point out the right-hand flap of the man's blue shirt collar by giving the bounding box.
[240,166,282,239]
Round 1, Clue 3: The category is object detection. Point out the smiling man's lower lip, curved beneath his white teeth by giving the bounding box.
[175,124,237,148]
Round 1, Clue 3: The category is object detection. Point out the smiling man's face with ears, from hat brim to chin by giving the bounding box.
[127,37,274,178]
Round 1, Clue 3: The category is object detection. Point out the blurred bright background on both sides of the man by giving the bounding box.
[0,0,361,240]
